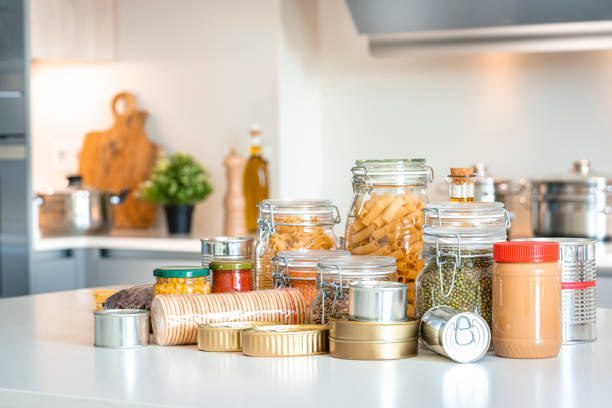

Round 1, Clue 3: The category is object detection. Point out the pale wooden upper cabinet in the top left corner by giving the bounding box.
[30,0,117,61]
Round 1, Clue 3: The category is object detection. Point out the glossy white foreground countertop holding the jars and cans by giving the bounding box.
[0,289,612,408]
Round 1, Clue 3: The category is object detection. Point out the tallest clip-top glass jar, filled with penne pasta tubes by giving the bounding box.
[344,159,433,315]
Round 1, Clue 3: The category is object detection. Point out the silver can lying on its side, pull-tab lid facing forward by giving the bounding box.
[419,306,491,363]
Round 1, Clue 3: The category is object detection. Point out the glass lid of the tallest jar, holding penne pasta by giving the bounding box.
[351,158,433,186]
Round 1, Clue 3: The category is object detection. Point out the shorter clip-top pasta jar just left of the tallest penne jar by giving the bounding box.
[255,200,340,290]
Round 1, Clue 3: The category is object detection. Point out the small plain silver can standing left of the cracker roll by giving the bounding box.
[94,309,150,348]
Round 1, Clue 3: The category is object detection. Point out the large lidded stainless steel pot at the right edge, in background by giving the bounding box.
[532,160,612,241]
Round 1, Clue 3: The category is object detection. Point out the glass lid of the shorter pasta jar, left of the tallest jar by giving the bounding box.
[257,200,340,226]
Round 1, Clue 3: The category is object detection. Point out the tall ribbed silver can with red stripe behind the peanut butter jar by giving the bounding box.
[517,238,597,344]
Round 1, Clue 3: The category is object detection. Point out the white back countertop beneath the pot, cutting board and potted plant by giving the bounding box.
[33,230,201,254]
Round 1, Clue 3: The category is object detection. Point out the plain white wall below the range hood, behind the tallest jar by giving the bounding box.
[310,0,612,225]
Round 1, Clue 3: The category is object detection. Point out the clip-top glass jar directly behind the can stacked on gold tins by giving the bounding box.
[310,255,397,324]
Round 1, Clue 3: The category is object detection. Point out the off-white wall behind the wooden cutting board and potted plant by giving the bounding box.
[31,0,279,235]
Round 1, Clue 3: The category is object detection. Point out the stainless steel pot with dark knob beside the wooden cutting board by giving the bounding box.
[36,176,128,236]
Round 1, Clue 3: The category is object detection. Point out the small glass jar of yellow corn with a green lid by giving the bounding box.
[153,266,210,296]
